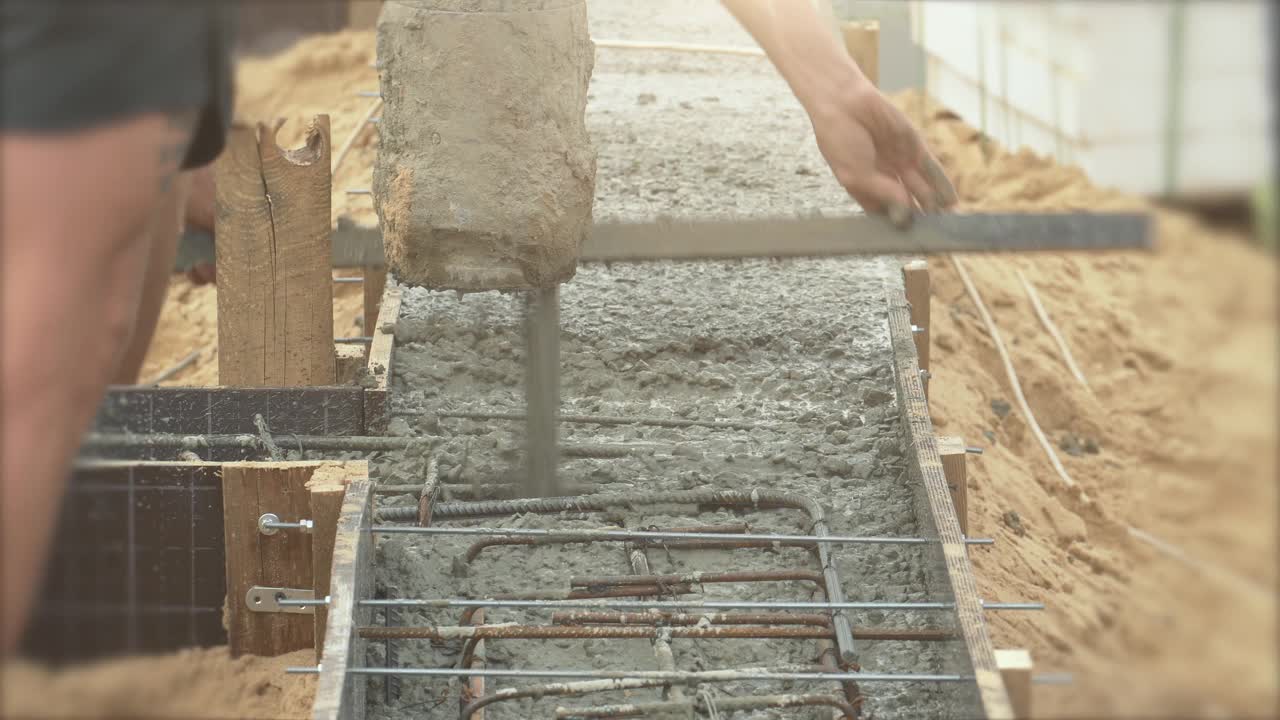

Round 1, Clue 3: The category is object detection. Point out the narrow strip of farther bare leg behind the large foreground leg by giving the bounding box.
[111,173,191,386]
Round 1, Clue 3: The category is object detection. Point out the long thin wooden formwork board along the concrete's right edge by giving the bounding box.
[886,275,1012,720]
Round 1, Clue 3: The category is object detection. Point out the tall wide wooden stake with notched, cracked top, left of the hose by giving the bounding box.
[214,115,335,387]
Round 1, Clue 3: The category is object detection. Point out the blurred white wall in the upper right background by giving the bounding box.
[913,0,1274,195]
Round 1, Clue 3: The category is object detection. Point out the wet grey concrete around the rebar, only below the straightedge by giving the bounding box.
[353,259,967,720]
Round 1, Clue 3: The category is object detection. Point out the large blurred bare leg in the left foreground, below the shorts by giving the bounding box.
[0,114,193,655]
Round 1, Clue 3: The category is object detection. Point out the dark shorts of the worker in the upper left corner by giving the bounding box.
[0,0,237,169]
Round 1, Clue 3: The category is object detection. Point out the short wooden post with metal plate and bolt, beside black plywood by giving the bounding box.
[223,462,316,657]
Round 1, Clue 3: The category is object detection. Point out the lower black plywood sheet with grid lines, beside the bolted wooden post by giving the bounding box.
[23,462,227,662]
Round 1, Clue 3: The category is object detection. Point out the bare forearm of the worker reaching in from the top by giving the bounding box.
[721,0,867,114]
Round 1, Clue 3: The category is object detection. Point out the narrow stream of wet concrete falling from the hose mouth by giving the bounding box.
[522,286,561,497]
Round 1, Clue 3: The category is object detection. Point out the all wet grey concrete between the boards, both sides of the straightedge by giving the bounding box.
[369,1,956,719]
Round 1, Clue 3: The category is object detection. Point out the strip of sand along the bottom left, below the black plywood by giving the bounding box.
[0,647,315,720]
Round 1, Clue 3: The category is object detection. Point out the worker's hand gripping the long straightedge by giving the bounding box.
[809,81,956,227]
